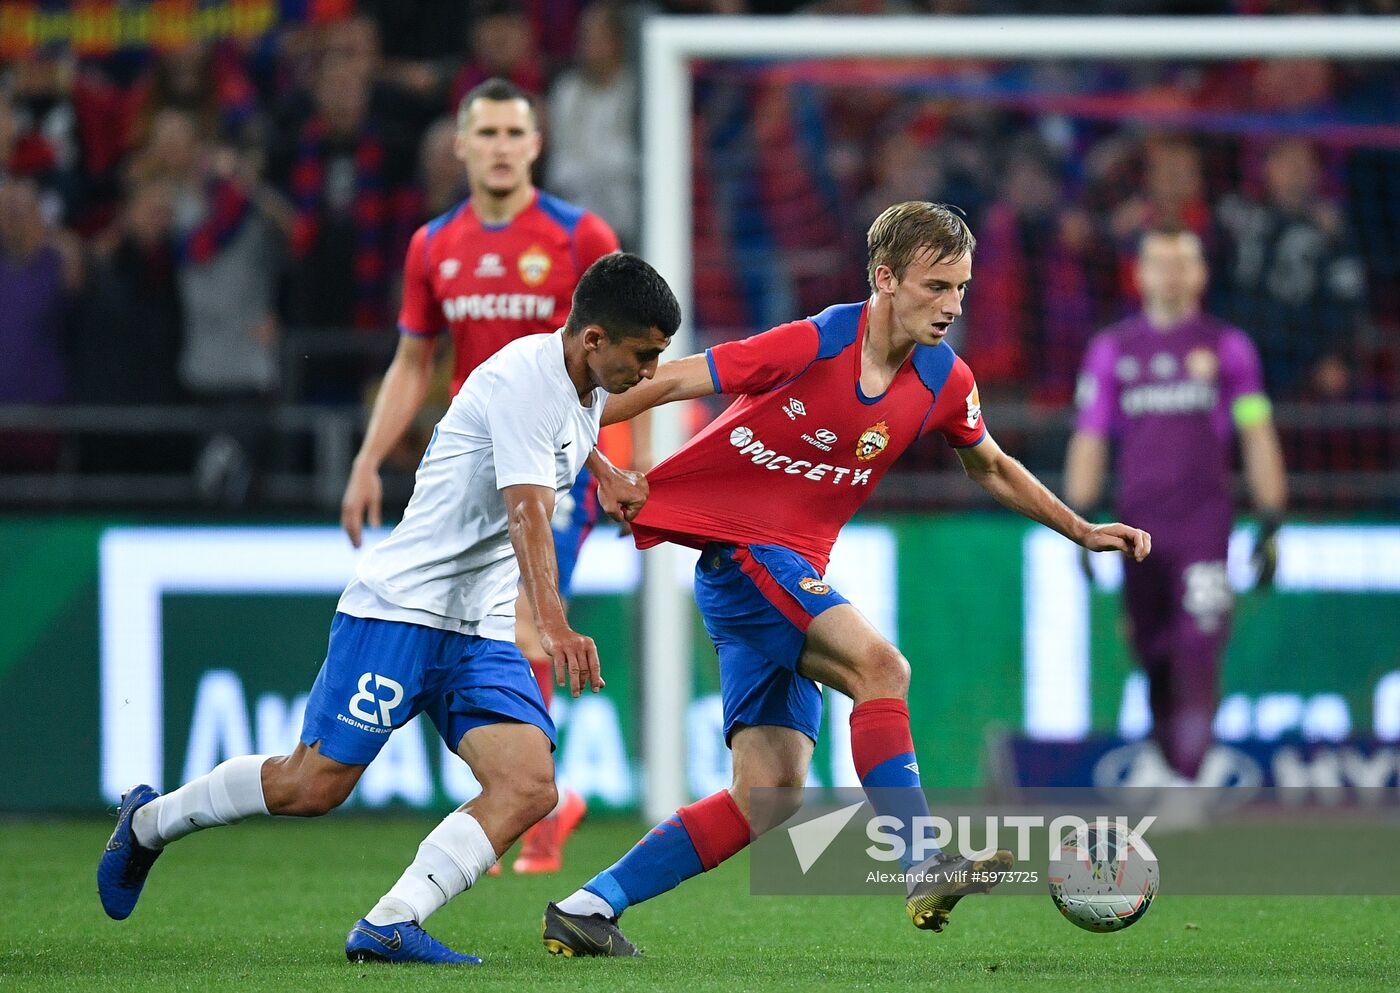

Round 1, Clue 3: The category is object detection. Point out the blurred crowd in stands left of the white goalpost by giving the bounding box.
[0,0,637,431]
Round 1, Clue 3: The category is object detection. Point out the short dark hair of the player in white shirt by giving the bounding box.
[564,252,680,343]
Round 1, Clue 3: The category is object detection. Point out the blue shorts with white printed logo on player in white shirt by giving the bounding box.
[301,612,554,765]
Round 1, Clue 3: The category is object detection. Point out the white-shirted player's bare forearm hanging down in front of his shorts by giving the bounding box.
[501,483,603,696]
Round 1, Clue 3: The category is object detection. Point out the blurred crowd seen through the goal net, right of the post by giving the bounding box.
[696,59,1400,406]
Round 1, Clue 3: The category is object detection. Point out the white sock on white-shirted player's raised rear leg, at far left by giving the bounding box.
[132,755,272,849]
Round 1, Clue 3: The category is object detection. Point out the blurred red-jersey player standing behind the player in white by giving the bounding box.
[340,80,617,873]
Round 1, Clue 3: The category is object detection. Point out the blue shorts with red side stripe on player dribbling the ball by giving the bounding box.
[696,542,850,744]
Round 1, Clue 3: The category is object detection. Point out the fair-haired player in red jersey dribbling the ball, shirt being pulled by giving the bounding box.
[542,202,1151,955]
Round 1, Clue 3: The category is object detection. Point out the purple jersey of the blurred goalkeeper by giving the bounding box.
[1077,314,1264,542]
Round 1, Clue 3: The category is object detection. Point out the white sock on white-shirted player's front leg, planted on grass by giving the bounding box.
[365,811,496,927]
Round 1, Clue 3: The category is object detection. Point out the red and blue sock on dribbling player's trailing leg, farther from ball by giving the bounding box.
[584,790,749,915]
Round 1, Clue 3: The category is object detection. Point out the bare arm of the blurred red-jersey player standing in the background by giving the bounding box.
[340,335,437,548]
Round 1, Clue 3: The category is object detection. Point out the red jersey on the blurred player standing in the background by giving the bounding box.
[399,190,617,394]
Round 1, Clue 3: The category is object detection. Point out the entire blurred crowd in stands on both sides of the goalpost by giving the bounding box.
[0,0,1400,495]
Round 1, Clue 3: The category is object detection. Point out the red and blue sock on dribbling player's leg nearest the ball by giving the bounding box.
[851,697,938,870]
